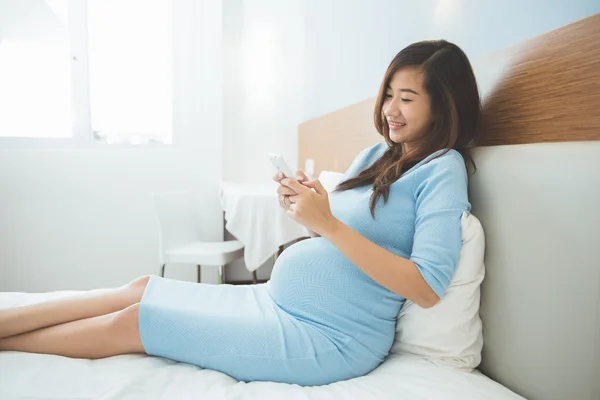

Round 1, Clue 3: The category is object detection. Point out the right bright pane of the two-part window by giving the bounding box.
[87,0,173,144]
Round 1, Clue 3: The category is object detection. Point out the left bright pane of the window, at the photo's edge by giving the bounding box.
[0,0,73,138]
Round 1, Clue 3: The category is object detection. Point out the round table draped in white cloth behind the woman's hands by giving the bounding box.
[220,181,310,272]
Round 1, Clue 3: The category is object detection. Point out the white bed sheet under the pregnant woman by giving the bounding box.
[0,291,523,400]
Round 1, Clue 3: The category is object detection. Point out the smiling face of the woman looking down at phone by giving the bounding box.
[382,67,431,149]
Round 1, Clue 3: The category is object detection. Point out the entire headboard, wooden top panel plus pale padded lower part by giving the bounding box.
[299,14,600,400]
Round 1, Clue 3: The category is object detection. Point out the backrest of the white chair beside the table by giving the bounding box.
[152,191,200,262]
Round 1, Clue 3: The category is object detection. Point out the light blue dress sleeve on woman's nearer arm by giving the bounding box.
[410,153,471,299]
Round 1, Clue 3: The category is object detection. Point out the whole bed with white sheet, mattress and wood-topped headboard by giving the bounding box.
[0,15,600,400]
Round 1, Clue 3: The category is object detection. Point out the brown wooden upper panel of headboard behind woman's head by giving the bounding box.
[298,14,600,175]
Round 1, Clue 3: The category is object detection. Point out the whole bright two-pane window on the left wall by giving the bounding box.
[0,0,173,144]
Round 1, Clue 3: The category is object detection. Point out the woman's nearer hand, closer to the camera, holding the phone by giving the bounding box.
[280,178,339,236]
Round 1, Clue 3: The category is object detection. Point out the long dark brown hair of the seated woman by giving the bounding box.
[336,40,481,218]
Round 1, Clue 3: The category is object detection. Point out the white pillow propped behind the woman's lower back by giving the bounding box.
[391,213,485,371]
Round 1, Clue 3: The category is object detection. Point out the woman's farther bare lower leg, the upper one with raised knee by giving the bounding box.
[0,276,150,339]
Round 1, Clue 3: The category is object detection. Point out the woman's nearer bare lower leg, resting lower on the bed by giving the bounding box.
[0,304,144,358]
